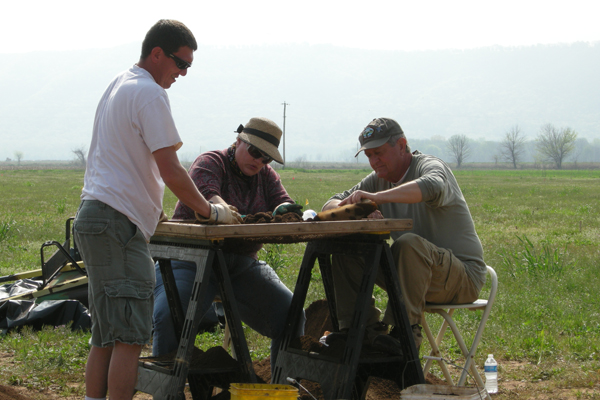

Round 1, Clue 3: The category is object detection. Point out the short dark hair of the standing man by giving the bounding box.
[140,19,198,60]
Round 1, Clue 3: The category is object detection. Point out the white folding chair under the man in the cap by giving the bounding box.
[421,265,498,399]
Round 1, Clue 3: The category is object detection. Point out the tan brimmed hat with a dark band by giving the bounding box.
[237,117,283,164]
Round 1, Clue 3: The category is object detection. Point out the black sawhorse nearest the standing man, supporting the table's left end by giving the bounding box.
[136,241,256,400]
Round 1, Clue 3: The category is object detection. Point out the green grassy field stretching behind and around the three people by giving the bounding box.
[0,169,600,399]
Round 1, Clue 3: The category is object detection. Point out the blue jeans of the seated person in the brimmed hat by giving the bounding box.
[152,253,305,367]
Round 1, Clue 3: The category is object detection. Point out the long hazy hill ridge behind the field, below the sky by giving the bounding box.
[0,43,600,162]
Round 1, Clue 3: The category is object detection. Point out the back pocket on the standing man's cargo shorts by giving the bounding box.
[73,218,111,267]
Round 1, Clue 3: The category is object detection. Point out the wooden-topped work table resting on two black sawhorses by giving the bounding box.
[136,219,424,400]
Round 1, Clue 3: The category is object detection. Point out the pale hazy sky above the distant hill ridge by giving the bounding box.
[0,0,600,53]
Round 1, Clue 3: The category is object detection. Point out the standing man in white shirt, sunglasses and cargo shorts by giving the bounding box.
[74,20,241,400]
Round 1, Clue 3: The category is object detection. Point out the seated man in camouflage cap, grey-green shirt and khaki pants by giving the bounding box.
[323,118,486,355]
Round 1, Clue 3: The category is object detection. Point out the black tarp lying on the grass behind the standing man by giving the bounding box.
[0,300,91,333]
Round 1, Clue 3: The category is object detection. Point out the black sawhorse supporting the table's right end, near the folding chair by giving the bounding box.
[273,235,425,399]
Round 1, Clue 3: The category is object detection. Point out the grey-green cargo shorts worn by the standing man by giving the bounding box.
[73,200,156,347]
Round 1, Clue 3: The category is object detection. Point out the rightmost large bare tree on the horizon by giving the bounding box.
[536,124,577,169]
